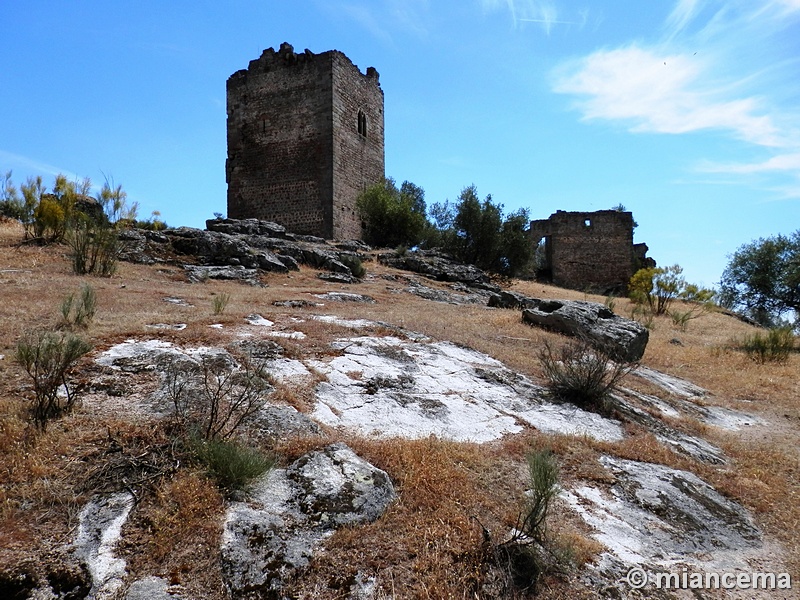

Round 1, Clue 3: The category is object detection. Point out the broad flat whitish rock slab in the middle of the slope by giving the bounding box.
[309,336,623,443]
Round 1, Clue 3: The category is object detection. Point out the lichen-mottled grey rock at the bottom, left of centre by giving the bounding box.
[222,444,396,599]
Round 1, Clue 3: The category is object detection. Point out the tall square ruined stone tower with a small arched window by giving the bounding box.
[225,43,384,238]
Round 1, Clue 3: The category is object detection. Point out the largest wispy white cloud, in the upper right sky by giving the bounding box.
[553,0,800,147]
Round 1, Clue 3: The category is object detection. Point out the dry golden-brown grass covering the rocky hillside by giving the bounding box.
[0,223,800,599]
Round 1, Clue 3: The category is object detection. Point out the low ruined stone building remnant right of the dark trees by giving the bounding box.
[530,210,634,293]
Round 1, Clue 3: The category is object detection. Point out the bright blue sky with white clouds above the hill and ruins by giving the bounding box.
[0,0,800,286]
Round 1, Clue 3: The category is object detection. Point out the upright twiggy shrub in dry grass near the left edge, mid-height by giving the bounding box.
[15,331,92,430]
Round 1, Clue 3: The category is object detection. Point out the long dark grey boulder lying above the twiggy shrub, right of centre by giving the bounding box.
[522,300,650,362]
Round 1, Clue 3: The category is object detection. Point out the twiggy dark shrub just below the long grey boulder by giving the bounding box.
[539,341,636,414]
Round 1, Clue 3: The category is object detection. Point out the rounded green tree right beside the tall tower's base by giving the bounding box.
[356,177,427,247]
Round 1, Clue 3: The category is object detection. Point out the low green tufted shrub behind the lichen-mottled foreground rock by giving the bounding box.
[190,438,275,491]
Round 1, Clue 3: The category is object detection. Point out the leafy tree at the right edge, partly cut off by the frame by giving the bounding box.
[719,230,800,328]
